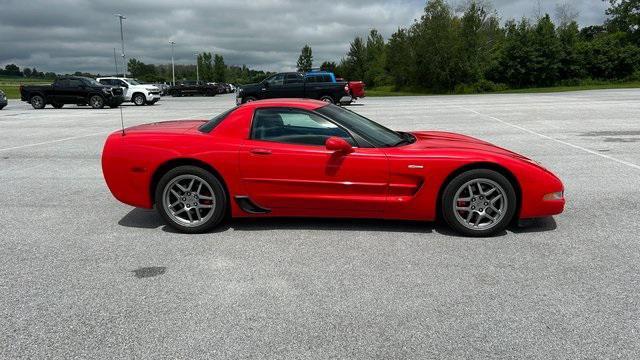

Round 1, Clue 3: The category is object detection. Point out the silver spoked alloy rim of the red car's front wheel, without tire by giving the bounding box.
[453,178,509,230]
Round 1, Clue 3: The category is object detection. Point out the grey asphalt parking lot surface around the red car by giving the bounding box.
[0,90,640,359]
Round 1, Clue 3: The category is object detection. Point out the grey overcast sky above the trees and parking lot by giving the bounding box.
[0,0,607,73]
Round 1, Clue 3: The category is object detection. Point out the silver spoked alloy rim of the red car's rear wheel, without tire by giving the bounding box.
[162,174,216,227]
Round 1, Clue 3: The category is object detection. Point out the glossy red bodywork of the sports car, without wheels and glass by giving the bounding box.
[102,99,564,220]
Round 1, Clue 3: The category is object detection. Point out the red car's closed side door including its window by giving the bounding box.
[240,108,389,215]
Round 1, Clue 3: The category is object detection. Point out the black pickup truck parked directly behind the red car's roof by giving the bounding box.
[236,72,351,105]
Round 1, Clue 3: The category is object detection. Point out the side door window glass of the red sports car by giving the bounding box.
[251,108,355,146]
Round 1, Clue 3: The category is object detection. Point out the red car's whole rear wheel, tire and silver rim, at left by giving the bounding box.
[155,166,227,233]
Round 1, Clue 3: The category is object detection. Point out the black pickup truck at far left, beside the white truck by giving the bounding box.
[20,76,124,109]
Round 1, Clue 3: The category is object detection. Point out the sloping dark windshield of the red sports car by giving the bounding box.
[316,104,409,147]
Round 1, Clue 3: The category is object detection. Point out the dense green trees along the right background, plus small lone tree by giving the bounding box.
[298,0,640,92]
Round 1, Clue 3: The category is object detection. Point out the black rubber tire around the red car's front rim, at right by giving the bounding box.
[441,169,518,237]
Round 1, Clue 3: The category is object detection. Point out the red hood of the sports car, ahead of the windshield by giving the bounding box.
[407,131,529,160]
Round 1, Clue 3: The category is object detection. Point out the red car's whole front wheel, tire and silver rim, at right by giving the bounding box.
[442,169,517,236]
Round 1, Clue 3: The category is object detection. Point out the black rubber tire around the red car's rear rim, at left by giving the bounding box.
[155,165,227,234]
